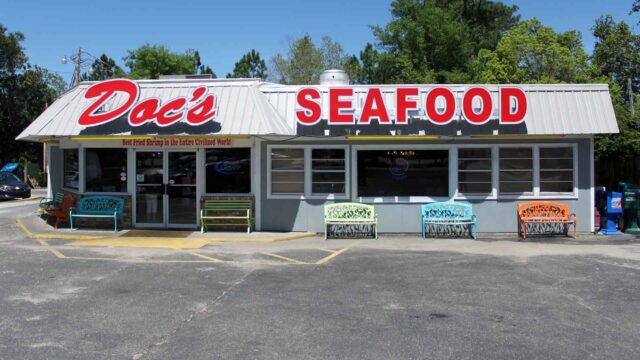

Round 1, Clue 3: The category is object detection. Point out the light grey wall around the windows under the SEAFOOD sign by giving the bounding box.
[259,138,593,233]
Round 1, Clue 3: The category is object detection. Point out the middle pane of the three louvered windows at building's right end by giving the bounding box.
[500,148,533,194]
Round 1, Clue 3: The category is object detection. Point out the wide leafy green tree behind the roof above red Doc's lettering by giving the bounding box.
[124,44,215,79]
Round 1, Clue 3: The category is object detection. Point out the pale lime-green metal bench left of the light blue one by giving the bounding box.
[324,203,378,240]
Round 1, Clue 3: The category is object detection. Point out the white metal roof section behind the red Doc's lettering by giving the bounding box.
[18,79,295,140]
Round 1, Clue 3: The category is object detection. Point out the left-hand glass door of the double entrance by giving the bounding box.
[136,151,165,227]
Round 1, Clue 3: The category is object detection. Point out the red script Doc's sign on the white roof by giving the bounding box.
[78,79,217,127]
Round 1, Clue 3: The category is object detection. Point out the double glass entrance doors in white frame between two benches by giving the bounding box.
[135,150,198,228]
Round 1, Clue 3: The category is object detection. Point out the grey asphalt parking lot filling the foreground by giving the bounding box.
[0,204,640,359]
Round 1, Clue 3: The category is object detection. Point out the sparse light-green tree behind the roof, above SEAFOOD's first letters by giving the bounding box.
[271,35,357,84]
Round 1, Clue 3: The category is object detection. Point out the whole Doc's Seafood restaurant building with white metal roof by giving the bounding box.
[18,70,618,233]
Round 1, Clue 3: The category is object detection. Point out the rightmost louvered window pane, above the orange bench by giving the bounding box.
[540,147,573,193]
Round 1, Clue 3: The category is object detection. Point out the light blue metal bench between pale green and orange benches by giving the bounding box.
[422,201,477,239]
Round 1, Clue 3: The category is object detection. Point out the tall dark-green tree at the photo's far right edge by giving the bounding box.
[592,15,640,102]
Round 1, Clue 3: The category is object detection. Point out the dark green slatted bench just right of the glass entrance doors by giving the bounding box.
[200,200,252,233]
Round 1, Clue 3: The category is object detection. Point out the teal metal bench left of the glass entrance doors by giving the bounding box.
[69,195,124,231]
